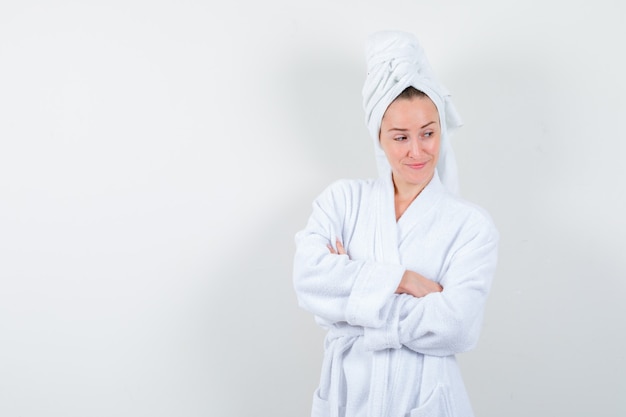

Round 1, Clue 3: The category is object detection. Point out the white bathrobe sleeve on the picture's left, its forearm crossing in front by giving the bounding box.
[293,180,405,328]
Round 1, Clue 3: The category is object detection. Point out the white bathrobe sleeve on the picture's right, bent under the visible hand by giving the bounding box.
[364,211,498,356]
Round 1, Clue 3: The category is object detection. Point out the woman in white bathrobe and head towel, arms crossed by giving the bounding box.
[294,31,498,417]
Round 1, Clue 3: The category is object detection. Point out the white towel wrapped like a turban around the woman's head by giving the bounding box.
[363,31,462,194]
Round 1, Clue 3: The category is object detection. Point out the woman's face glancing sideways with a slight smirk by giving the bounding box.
[380,96,441,193]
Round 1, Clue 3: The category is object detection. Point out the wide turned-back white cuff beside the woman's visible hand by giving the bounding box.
[346,262,406,328]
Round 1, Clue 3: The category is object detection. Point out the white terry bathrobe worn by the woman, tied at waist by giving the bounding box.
[293,173,498,417]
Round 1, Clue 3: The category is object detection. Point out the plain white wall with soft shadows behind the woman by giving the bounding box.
[0,0,626,417]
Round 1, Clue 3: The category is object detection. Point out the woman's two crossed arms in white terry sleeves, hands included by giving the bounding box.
[294,181,498,356]
